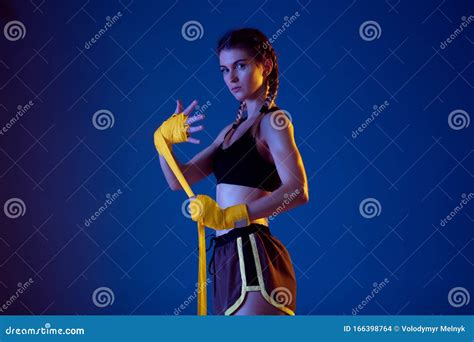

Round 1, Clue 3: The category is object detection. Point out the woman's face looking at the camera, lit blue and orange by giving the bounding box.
[219,48,265,101]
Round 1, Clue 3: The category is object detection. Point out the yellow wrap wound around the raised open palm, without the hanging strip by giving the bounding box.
[154,113,189,155]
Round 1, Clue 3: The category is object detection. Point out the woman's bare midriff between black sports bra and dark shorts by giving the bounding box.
[216,183,269,236]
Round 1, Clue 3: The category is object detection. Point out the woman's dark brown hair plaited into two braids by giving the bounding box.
[217,28,279,137]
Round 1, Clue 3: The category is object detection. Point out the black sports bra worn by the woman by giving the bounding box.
[212,107,281,191]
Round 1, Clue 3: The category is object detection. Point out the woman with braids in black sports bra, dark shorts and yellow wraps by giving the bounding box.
[155,29,308,315]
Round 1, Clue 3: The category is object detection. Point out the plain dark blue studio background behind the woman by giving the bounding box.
[0,0,474,315]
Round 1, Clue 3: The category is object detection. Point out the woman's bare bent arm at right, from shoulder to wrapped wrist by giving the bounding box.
[247,112,309,220]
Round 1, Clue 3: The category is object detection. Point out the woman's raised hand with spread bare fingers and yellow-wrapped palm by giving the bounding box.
[154,100,204,154]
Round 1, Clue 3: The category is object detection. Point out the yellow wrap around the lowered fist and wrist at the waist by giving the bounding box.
[190,195,250,230]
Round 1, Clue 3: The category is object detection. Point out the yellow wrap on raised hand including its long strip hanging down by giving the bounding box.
[154,113,207,316]
